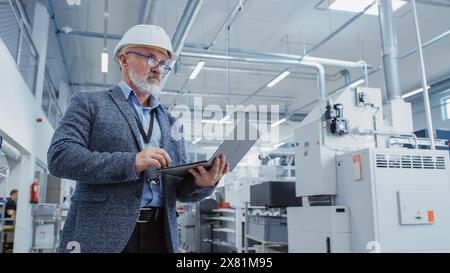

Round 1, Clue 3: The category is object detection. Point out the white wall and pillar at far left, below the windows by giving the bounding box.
[0,39,54,252]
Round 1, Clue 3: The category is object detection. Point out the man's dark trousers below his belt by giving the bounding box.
[122,209,168,253]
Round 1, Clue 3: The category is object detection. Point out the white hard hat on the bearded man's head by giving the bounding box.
[114,25,175,62]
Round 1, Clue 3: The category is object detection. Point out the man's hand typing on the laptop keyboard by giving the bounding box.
[134,147,172,173]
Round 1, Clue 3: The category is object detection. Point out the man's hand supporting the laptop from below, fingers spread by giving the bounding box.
[188,155,229,187]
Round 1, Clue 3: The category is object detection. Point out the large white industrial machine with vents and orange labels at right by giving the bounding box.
[288,87,450,252]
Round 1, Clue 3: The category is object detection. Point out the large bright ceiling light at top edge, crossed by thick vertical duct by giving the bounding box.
[329,0,408,16]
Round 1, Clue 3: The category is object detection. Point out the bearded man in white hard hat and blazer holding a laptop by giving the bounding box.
[48,25,229,253]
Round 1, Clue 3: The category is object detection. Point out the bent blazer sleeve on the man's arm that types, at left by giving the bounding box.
[47,92,140,184]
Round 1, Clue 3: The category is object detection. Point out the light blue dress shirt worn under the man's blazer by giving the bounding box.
[118,81,163,208]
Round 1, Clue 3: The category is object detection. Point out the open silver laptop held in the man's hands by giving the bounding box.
[155,119,260,176]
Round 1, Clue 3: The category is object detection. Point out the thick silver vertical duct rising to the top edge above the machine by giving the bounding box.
[378,0,402,101]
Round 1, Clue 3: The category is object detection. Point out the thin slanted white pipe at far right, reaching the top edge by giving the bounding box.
[411,0,436,150]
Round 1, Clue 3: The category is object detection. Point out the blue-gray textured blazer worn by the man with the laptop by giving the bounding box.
[47,86,214,252]
